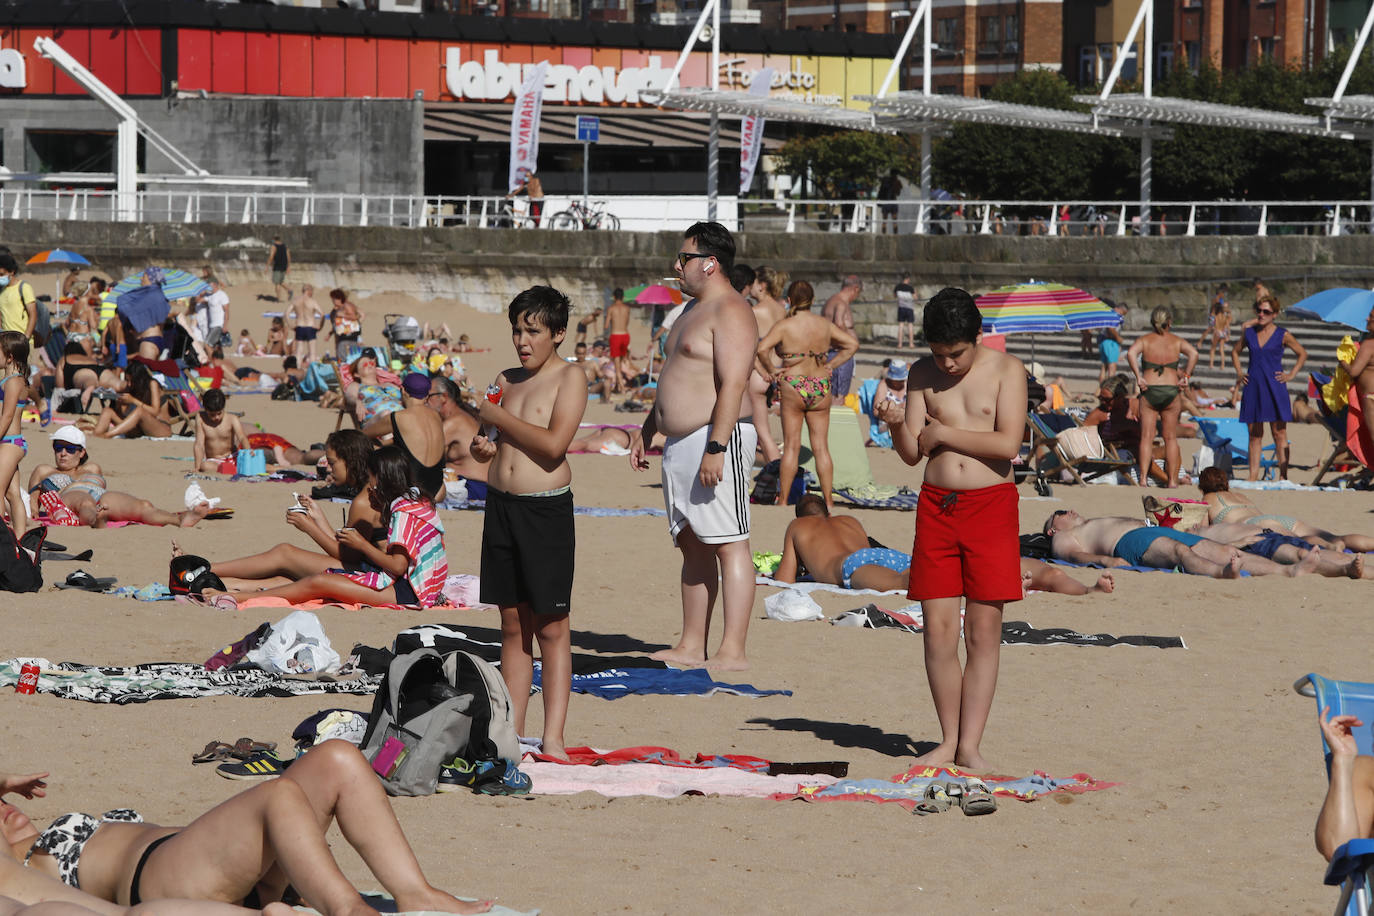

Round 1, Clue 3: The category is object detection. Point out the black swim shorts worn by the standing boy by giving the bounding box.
[481,486,576,614]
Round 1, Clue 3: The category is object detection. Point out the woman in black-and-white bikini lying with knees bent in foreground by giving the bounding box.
[0,740,491,916]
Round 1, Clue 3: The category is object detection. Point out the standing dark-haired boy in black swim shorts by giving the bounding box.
[470,286,587,758]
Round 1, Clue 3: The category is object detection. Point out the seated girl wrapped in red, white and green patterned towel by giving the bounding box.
[205,445,448,608]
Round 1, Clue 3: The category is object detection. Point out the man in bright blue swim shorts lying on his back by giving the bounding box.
[1044,509,1322,578]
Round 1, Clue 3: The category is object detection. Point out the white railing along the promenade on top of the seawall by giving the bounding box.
[0,185,1374,238]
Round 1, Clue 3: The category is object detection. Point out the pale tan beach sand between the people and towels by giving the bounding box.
[0,283,1374,916]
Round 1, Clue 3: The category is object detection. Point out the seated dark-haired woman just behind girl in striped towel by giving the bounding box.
[210,430,386,588]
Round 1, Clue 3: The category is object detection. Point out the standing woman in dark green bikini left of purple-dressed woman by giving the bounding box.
[1125,305,1198,488]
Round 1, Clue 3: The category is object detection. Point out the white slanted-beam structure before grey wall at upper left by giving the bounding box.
[33,36,311,222]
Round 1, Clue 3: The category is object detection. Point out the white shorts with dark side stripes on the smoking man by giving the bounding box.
[664,420,758,544]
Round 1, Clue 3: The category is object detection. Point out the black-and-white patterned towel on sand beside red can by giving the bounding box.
[0,658,382,706]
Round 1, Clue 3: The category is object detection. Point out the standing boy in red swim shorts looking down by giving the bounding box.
[878,287,1026,770]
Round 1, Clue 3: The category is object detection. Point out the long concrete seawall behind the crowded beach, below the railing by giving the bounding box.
[0,220,1374,339]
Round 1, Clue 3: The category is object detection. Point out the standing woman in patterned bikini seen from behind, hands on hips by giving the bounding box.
[757,280,859,509]
